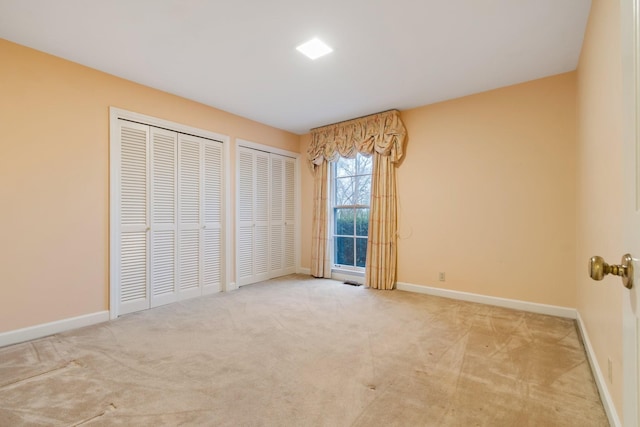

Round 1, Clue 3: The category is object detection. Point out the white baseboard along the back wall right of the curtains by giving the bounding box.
[396,282,577,319]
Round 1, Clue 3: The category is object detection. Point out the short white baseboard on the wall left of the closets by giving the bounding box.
[0,310,109,347]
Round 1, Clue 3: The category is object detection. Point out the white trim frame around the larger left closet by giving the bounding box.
[109,107,235,319]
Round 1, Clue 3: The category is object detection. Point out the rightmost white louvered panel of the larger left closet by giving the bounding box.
[201,141,224,294]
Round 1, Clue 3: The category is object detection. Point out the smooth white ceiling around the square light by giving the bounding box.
[0,0,591,133]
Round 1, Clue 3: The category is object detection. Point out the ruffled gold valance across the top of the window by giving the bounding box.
[307,110,407,168]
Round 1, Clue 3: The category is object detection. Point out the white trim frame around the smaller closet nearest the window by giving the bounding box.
[234,138,302,288]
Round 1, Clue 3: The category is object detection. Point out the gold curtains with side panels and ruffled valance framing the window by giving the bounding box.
[307,110,407,289]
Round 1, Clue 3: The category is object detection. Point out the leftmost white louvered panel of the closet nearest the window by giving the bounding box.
[236,147,255,286]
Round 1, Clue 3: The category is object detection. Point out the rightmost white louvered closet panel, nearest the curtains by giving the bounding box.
[283,157,297,274]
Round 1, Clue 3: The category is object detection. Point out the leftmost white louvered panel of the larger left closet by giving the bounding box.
[116,120,149,314]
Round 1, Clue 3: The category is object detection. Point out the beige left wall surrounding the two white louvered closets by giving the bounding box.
[0,39,299,332]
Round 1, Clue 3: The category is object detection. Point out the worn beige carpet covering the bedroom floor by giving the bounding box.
[0,276,608,427]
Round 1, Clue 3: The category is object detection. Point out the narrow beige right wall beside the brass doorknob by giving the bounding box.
[576,0,624,415]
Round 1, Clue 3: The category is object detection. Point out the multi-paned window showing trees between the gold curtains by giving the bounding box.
[331,154,373,270]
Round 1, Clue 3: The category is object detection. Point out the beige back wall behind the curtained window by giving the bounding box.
[301,73,576,307]
